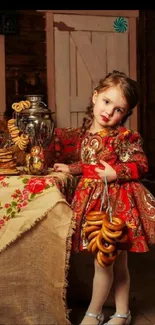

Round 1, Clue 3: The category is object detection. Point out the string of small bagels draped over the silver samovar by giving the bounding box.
[8,100,31,150]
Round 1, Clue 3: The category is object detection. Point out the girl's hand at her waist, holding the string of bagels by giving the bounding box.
[95,160,117,183]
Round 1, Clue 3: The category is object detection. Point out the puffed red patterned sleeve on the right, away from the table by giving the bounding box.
[113,131,148,180]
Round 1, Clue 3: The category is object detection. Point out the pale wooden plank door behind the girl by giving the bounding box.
[54,14,129,127]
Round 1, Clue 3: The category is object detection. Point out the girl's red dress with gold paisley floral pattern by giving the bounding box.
[69,127,155,252]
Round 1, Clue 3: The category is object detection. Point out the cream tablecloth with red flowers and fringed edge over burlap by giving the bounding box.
[0,170,75,251]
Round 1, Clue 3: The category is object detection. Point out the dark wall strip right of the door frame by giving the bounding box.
[138,10,155,180]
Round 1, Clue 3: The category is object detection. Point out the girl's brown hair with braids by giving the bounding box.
[81,70,139,134]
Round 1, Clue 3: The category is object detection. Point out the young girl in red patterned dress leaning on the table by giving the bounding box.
[54,71,155,325]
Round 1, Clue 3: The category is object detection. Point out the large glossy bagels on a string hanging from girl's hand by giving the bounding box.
[83,177,128,267]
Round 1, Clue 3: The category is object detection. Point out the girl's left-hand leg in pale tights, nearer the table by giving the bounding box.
[81,259,113,325]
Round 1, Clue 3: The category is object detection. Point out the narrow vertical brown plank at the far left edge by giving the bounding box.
[0,35,6,115]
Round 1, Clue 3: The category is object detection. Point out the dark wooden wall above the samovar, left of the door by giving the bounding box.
[5,10,47,117]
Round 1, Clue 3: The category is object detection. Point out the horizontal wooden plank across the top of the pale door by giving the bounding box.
[54,14,128,32]
